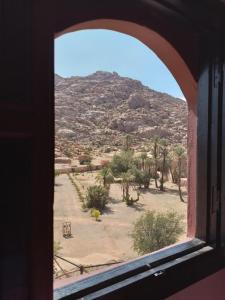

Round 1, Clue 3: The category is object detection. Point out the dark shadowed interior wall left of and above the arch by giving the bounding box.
[0,0,222,300]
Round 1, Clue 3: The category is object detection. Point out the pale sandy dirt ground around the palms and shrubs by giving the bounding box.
[54,172,187,272]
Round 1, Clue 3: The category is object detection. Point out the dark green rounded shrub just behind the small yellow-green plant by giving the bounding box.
[85,185,108,211]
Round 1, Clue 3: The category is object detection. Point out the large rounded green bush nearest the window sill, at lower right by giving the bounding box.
[131,211,184,254]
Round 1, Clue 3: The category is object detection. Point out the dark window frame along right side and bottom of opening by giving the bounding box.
[54,10,225,300]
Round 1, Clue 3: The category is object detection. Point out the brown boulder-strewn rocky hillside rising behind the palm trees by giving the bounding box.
[55,71,187,148]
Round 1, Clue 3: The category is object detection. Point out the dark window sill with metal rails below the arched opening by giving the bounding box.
[54,239,225,300]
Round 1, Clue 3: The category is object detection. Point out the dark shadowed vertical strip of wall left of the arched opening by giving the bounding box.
[0,0,54,300]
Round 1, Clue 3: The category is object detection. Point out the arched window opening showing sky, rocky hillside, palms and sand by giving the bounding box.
[54,30,188,280]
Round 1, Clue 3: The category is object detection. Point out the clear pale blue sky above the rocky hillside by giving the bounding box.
[55,29,184,99]
